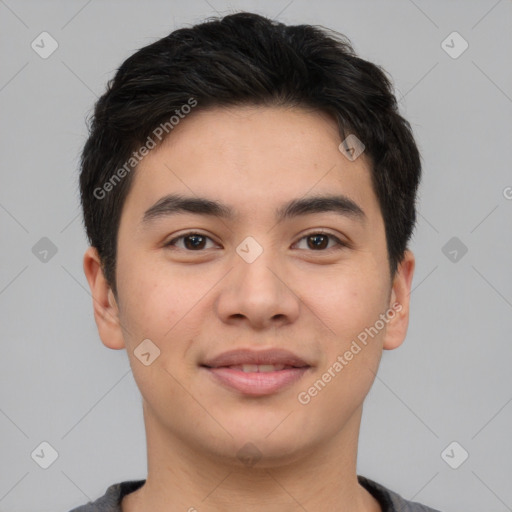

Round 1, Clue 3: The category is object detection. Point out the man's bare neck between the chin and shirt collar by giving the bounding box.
[122,405,381,512]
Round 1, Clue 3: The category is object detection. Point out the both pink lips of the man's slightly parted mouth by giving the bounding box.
[201,349,311,396]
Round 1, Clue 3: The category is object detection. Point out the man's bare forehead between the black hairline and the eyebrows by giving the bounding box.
[125,106,379,226]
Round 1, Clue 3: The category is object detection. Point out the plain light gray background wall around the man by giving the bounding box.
[0,0,512,512]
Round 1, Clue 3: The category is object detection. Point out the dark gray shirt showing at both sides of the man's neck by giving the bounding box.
[70,475,439,512]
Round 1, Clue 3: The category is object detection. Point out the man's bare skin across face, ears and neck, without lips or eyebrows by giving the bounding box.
[84,107,414,512]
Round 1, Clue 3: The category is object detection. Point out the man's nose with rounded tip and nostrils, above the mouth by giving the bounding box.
[216,246,301,330]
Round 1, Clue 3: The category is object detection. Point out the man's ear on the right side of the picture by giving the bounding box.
[383,250,415,350]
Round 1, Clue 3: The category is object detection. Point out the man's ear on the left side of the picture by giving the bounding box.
[84,247,125,350]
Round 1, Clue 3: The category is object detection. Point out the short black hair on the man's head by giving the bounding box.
[80,12,421,294]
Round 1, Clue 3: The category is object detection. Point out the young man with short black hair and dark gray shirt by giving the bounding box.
[71,9,440,512]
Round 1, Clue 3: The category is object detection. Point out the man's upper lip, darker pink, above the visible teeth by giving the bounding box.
[202,349,310,368]
